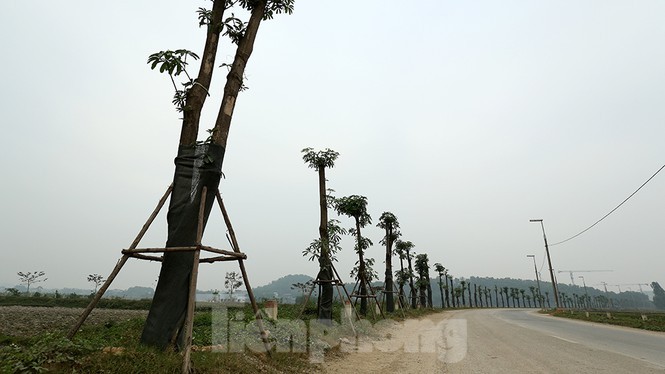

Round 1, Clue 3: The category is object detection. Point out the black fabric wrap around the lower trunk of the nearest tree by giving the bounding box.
[141,144,224,350]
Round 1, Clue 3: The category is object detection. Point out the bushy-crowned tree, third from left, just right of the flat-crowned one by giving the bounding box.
[335,195,372,316]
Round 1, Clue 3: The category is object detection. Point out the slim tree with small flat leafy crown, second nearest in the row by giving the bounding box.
[302,148,343,320]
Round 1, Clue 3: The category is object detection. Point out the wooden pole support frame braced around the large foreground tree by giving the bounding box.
[67,184,270,373]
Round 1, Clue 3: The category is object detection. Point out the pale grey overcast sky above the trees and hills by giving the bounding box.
[0,0,665,296]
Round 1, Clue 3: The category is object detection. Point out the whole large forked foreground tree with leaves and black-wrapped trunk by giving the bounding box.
[141,0,294,349]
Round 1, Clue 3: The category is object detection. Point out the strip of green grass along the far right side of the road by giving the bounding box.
[548,310,665,331]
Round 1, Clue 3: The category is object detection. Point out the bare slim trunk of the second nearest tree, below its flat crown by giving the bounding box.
[318,166,334,321]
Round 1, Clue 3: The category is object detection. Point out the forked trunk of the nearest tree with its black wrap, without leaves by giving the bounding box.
[141,0,266,349]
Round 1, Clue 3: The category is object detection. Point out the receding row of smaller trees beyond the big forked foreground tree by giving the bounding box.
[302,148,550,319]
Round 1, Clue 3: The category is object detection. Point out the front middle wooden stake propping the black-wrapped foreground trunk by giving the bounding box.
[182,186,208,374]
